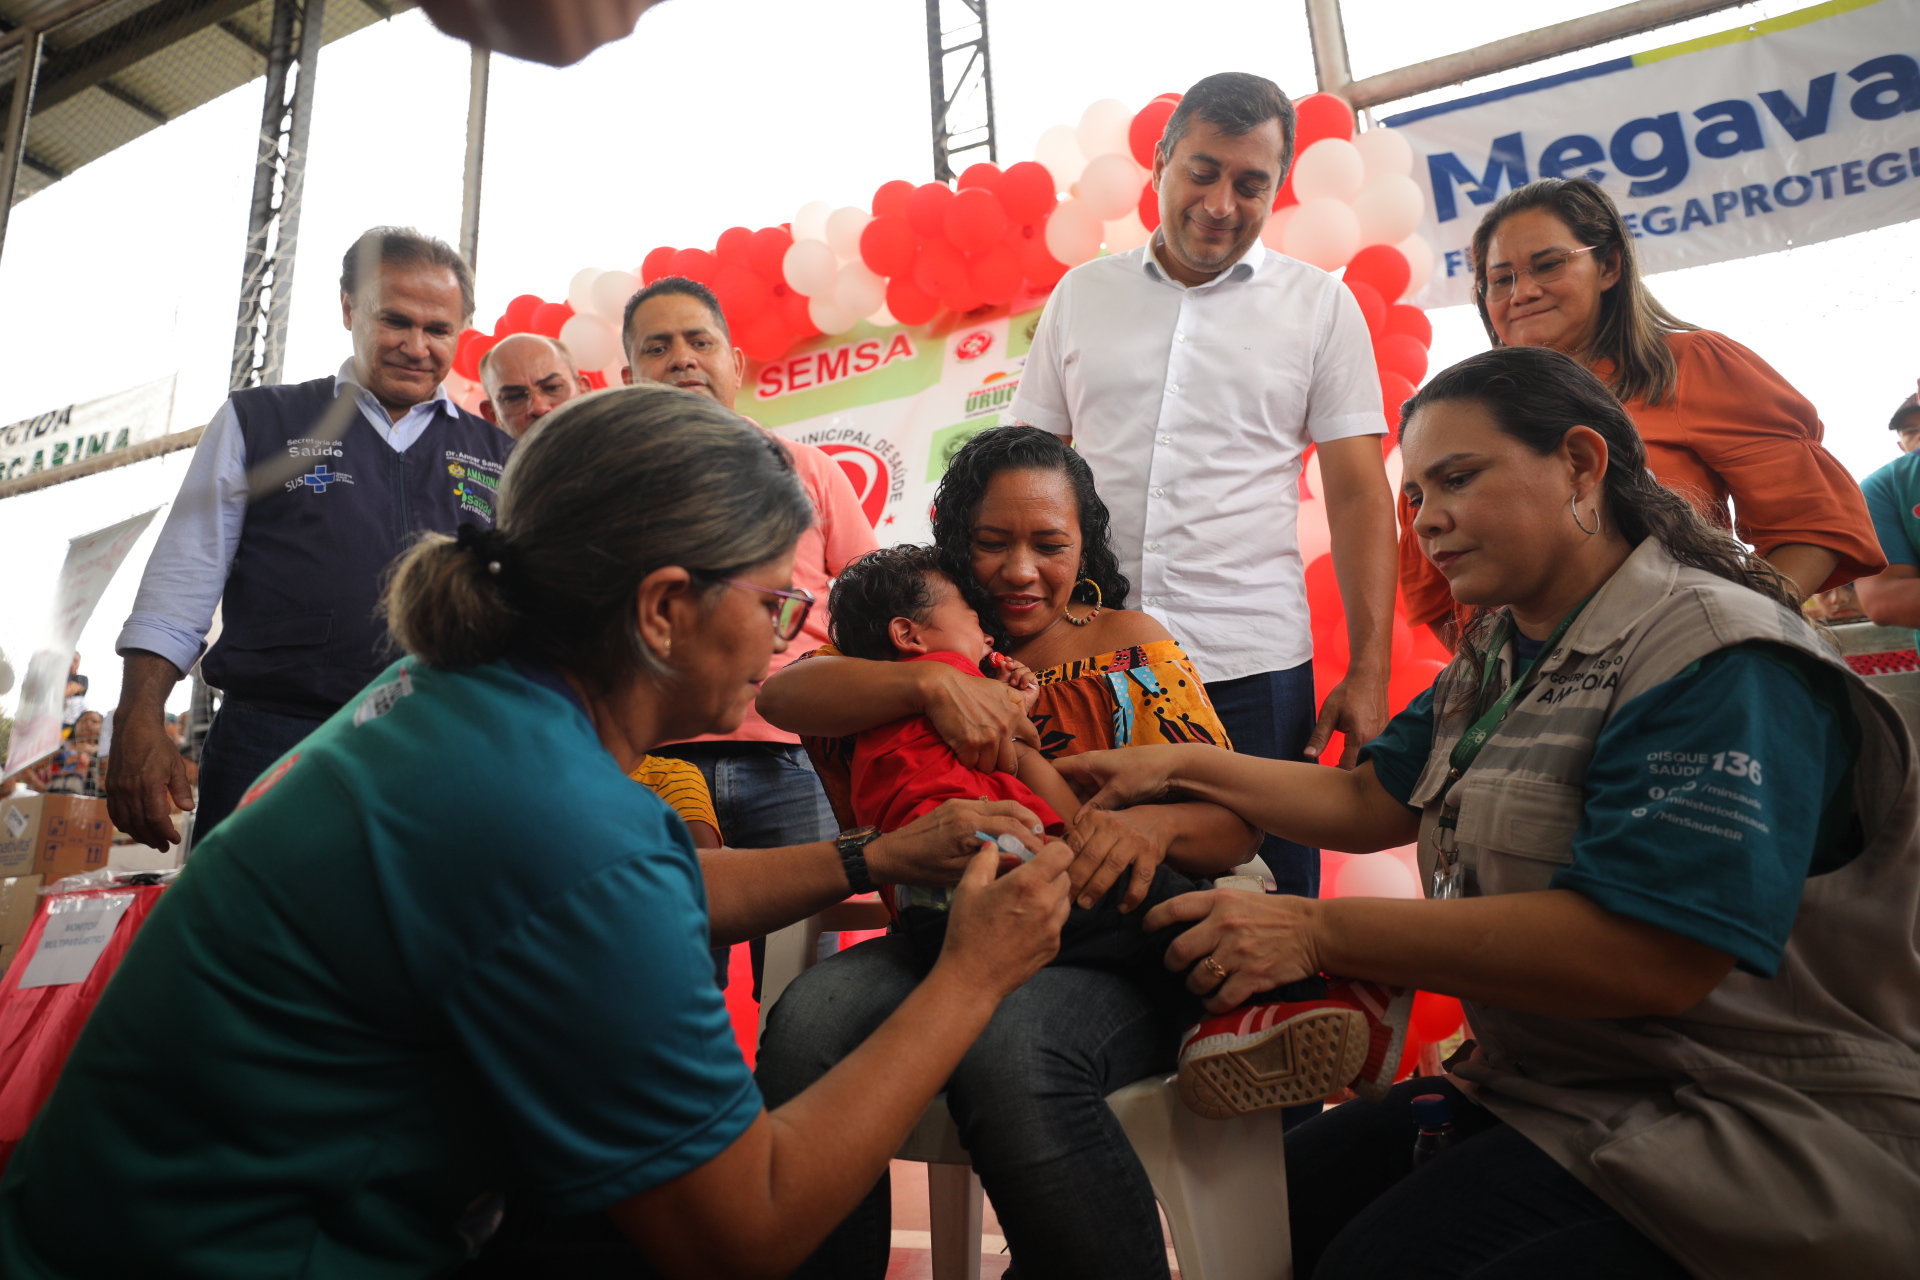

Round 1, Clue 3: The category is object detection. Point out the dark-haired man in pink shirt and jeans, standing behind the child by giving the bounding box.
[620,276,879,1000]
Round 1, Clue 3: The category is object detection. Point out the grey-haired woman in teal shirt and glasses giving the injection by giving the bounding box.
[0,388,1069,1280]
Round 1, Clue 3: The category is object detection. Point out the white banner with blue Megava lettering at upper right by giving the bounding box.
[1380,0,1920,307]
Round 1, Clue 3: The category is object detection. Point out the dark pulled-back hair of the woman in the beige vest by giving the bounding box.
[1400,347,1799,702]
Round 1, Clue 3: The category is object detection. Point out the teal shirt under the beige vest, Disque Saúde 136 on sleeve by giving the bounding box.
[1359,645,1860,977]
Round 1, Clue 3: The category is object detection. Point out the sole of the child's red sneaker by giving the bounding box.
[1179,1007,1369,1121]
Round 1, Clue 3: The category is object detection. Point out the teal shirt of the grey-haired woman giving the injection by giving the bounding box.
[0,658,762,1280]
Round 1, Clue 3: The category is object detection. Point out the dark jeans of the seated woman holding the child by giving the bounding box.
[755,935,1181,1280]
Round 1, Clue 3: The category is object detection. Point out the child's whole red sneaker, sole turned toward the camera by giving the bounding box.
[1179,979,1413,1121]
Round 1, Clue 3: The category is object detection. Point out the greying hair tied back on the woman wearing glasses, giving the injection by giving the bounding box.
[386,386,814,693]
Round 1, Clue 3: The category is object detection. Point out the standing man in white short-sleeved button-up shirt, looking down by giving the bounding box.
[1006,73,1394,896]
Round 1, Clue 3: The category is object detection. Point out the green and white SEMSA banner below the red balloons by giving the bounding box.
[752,307,1041,545]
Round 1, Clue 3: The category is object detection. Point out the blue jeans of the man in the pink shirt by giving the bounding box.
[653,743,839,1000]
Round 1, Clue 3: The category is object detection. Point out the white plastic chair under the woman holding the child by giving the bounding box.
[760,858,1294,1280]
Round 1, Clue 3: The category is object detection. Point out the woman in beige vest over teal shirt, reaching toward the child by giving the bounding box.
[1062,347,1920,1280]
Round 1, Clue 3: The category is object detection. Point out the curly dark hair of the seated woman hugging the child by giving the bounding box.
[933,426,1133,621]
